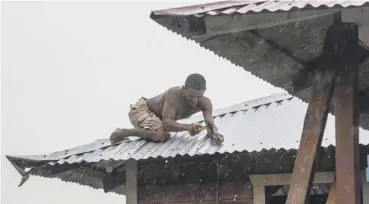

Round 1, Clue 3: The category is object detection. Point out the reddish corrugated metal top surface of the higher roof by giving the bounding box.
[153,0,369,17]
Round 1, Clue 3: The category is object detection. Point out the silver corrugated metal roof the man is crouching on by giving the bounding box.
[7,94,369,165]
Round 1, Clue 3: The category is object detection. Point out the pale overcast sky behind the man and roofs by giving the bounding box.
[1,1,281,204]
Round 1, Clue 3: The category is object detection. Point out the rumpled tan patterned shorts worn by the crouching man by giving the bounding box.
[128,97,163,130]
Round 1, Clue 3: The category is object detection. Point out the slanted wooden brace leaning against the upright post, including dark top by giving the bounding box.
[286,18,350,204]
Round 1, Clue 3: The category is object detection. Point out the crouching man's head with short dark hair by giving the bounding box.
[183,74,206,107]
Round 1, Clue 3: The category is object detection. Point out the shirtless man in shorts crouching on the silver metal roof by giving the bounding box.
[110,74,220,143]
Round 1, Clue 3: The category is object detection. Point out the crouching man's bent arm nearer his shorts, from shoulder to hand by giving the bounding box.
[162,88,191,132]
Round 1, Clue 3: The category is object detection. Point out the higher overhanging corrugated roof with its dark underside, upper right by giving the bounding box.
[151,0,369,130]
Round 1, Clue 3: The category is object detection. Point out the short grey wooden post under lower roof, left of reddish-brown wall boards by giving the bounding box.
[126,159,138,204]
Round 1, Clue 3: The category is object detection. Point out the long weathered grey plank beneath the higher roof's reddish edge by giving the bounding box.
[187,7,369,39]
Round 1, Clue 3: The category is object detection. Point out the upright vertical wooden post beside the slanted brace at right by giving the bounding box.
[334,23,361,204]
